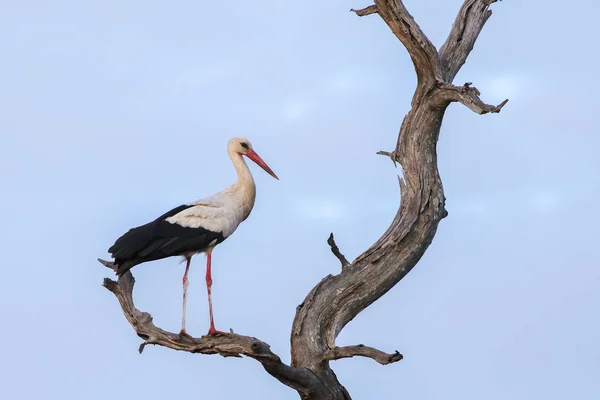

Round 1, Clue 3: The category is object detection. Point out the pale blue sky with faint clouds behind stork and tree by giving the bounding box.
[0,0,600,400]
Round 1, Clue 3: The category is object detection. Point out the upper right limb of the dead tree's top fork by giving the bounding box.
[440,0,497,82]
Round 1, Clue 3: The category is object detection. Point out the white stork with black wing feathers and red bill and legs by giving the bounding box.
[108,136,279,337]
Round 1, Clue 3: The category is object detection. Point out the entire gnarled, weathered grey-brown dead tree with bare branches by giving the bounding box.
[101,0,508,400]
